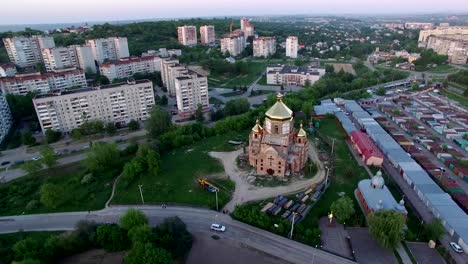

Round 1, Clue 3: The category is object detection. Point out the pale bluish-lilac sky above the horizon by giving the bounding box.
[0,0,468,25]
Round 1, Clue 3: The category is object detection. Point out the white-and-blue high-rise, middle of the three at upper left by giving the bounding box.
[42,45,96,73]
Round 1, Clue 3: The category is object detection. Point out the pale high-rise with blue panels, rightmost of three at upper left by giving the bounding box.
[86,37,130,63]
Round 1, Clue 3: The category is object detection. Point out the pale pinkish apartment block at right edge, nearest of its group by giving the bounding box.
[426,34,468,64]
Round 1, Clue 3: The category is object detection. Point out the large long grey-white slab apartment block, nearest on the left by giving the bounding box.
[33,80,155,133]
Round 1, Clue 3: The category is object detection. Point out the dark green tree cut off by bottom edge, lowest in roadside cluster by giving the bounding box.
[124,242,172,264]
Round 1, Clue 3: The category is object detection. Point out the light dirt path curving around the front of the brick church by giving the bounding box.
[209,143,326,212]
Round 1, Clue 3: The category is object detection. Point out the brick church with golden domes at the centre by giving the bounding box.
[249,94,308,177]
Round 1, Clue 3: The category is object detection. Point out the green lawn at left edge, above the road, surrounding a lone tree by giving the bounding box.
[0,163,116,215]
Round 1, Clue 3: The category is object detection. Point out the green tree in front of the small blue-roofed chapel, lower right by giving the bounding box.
[368,210,405,249]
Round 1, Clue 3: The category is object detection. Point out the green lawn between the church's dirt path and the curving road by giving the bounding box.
[112,132,247,208]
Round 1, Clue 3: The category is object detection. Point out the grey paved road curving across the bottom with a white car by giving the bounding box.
[0,206,354,264]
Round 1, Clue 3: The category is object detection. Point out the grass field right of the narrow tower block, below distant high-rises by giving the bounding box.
[208,61,270,88]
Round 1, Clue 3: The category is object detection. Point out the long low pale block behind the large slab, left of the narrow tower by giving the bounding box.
[99,55,161,80]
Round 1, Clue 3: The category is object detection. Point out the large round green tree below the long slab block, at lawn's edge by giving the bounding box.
[84,143,120,173]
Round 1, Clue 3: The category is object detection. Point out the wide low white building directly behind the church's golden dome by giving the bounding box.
[266,65,325,86]
